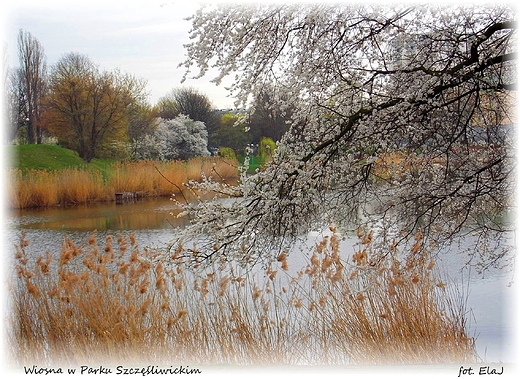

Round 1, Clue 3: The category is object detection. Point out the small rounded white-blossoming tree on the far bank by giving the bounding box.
[130,115,210,160]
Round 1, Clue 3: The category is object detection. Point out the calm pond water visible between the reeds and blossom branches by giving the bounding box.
[6,198,516,362]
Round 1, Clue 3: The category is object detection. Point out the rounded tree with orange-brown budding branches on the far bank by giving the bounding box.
[41,53,145,162]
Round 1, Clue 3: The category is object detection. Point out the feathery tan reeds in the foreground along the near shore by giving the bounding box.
[7,227,475,365]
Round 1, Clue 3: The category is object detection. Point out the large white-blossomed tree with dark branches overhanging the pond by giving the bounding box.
[176,4,516,270]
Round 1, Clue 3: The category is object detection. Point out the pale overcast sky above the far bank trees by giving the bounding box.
[2,0,238,108]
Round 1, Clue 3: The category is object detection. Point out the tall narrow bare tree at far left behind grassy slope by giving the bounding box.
[18,29,47,143]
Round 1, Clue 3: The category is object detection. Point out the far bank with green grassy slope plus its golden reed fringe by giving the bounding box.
[6,145,237,208]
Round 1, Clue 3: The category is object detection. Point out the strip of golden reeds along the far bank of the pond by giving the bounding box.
[8,158,237,208]
